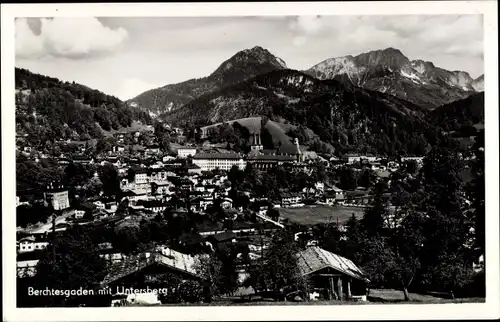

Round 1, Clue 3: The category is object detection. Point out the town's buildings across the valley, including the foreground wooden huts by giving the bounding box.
[17,124,434,299]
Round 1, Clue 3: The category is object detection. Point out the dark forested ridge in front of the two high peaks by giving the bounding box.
[164,70,439,155]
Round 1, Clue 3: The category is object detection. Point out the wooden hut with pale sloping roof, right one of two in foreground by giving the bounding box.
[298,246,370,301]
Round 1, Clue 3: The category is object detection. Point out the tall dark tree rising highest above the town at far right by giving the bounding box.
[422,147,472,294]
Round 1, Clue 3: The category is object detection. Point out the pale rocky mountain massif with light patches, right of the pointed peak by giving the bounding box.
[305,48,484,109]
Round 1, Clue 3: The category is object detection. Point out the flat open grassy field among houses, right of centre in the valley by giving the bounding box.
[280,205,363,226]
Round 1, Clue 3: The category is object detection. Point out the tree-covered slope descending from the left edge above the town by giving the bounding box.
[15,68,151,144]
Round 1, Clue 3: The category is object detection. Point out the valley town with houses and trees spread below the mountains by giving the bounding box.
[16,117,484,306]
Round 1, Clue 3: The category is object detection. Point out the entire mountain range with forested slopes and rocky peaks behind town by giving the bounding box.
[16,47,484,155]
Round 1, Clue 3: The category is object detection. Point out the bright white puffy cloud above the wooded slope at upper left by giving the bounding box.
[16,17,128,59]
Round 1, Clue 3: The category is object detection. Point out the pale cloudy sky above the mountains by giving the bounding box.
[15,15,484,100]
